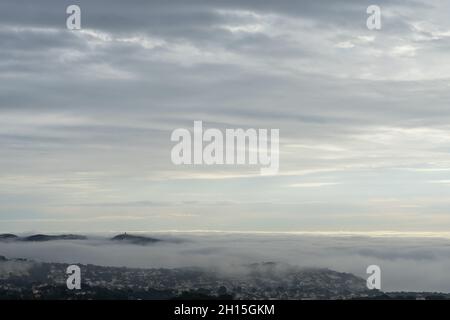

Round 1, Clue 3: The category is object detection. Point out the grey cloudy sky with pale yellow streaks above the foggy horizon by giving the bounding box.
[0,0,450,234]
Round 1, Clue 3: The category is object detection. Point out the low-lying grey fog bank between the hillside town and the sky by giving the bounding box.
[0,234,450,292]
